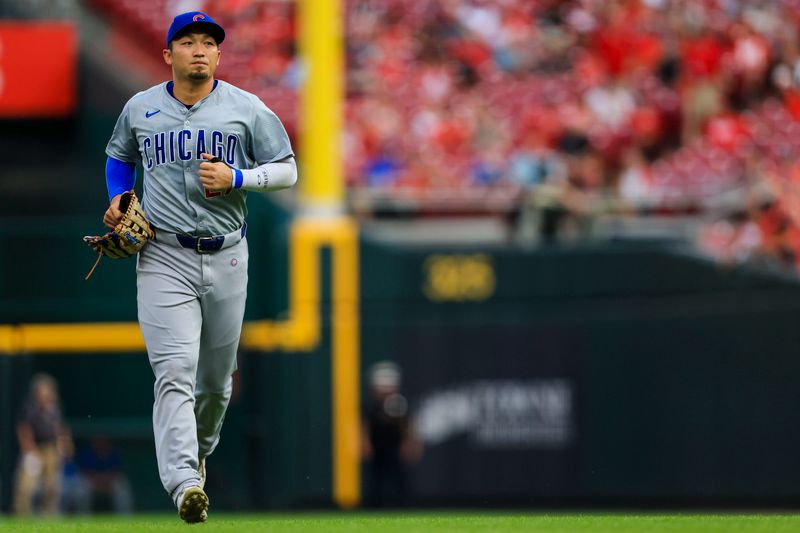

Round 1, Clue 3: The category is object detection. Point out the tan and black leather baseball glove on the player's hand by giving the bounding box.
[83,191,155,280]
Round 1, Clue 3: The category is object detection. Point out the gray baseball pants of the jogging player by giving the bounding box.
[136,236,248,501]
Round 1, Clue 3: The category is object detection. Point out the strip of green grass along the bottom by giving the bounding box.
[0,512,800,533]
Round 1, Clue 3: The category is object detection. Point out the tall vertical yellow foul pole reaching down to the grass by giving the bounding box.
[298,0,361,508]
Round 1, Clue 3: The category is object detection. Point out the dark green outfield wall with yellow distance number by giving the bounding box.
[0,199,800,510]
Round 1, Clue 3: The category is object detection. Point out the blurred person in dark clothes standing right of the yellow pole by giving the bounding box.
[362,362,422,507]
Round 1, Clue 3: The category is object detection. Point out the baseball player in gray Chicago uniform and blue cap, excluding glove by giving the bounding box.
[103,11,297,522]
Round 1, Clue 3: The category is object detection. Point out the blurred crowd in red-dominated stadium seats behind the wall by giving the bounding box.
[86,0,800,272]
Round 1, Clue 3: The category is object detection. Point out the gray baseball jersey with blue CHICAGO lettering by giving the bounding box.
[106,80,293,236]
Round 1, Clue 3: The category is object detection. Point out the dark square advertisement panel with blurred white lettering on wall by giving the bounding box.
[398,324,580,502]
